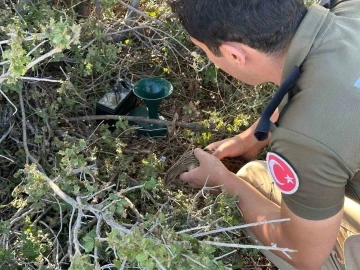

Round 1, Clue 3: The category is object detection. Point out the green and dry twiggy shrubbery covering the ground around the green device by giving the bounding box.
[0,0,316,270]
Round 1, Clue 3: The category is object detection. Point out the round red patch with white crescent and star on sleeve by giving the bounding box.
[266,152,299,194]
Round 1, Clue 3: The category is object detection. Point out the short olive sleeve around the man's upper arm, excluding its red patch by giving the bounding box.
[271,127,352,220]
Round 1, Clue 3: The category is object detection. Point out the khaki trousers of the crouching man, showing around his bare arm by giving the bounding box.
[237,161,360,270]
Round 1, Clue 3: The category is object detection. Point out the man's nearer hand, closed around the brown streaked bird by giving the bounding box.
[180,148,230,188]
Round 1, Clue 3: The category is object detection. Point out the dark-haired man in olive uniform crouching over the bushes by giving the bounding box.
[172,0,360,269]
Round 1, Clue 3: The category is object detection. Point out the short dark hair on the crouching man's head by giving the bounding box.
[170,0,307,56]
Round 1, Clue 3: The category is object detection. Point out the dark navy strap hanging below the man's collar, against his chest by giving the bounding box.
[254,66,300,141]
